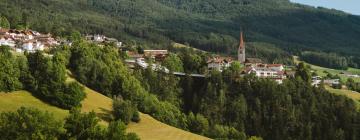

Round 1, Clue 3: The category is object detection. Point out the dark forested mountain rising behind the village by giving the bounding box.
[0,0,360,59]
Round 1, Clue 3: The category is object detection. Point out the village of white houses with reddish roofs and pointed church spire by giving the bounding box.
[0,28,340,86]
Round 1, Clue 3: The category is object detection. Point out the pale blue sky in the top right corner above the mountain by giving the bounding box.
[290,0,360,15]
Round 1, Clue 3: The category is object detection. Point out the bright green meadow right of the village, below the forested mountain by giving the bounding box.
[294,56,360,82]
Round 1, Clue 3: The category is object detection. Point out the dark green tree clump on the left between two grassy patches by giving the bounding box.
[25,52,86,109]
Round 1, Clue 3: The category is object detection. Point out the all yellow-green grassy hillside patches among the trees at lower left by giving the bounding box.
[0,87,208,140]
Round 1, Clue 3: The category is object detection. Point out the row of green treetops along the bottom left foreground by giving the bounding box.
[0,107,139,140]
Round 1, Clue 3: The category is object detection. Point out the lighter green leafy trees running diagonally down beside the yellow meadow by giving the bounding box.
[69,41,186,127]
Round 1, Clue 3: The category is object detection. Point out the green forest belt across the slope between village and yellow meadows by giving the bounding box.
[0,39,360,140]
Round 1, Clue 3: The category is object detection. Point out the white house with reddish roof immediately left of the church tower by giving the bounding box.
[207,57,233,72]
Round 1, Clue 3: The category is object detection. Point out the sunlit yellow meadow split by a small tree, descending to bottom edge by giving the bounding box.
[77,80,208,140]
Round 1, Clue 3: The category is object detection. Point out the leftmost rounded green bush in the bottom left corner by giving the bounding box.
[0,107,64,140]
